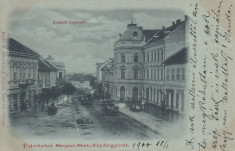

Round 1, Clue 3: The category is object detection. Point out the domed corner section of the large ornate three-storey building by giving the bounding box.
[114,23,158,101]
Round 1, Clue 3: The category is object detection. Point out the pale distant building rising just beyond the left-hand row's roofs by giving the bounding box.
[46,55,65,80]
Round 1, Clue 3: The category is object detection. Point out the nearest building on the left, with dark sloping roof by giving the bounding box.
[8,38,39,112]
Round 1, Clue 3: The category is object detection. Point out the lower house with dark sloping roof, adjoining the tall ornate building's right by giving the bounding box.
[162,48,188,112]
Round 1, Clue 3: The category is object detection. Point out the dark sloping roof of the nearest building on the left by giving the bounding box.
[7,38,40,59]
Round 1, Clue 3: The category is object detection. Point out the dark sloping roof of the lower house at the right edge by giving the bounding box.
[162,48,188,65]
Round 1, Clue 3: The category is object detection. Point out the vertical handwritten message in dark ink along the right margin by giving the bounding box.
[185,0,234,151]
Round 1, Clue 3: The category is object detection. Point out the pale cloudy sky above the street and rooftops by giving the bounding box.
[8,8,184,74]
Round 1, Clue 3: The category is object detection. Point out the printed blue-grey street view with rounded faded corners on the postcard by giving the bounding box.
[7,9,189,140]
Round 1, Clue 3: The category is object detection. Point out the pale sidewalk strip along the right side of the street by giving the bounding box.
[116,103,185,138]
